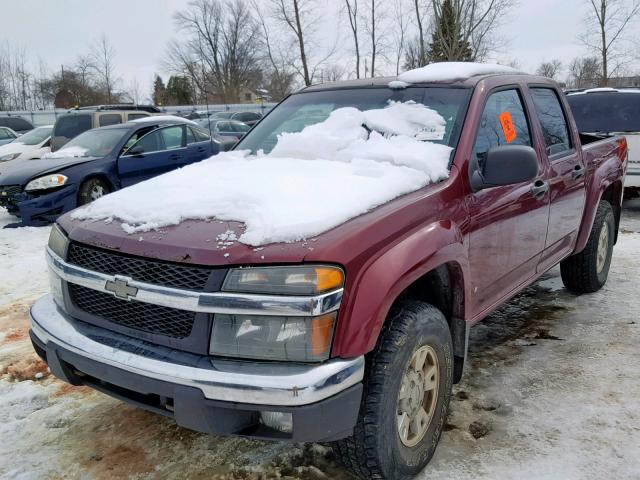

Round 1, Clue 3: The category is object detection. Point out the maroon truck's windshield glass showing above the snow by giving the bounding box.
[236,87,470,153]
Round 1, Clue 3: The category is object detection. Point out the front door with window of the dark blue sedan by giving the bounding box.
[118,125,189,187]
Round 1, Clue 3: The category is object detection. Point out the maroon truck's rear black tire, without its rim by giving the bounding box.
[560,200,616,293]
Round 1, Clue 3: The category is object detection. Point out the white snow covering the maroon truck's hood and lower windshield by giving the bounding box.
[71,102,452,246]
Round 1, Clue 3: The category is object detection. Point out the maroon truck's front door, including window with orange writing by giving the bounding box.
[467,86,549,315]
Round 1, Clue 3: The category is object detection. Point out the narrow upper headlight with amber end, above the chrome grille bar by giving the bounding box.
[222,265,344,295]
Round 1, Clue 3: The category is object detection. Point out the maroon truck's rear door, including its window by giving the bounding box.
[529,85,586,271]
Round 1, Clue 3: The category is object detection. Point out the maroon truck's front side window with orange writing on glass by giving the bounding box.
[473,89,531,161]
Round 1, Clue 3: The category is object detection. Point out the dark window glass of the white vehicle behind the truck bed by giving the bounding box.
[567,92,640,133]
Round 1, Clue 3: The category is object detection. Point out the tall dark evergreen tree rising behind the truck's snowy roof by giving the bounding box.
[428,0,473,62]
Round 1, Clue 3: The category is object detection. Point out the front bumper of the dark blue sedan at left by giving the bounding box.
[0,185,78,226]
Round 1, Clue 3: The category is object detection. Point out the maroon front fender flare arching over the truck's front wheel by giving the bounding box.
[334,221,469,380]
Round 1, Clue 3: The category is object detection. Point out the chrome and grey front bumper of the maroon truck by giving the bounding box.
[31,295,364,441]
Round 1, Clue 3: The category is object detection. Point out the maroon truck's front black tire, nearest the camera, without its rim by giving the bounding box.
[333,301,453,479]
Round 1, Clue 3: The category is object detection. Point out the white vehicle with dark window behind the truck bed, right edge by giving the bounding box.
[567,88,640,196]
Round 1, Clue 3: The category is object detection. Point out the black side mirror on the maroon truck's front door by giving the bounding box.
[470,145,538,191]
